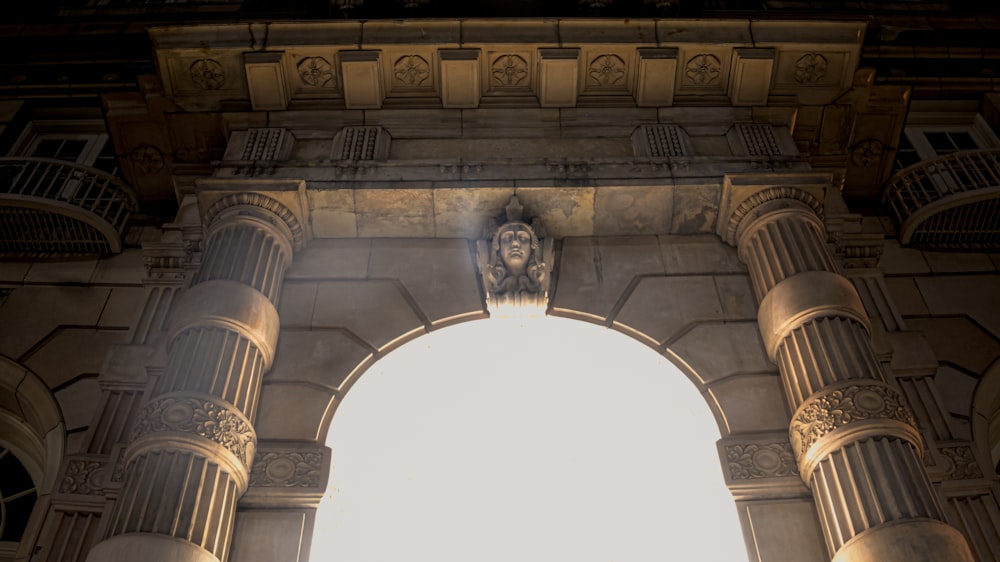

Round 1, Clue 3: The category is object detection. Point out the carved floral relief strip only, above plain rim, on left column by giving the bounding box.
[132,396,257,468]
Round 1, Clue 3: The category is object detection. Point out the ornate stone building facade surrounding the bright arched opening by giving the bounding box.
[0,3,1000,562]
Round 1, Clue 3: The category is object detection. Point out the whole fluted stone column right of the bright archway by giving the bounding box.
[729,188,973,562]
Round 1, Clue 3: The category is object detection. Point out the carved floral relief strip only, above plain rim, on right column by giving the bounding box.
[788,384,917,456]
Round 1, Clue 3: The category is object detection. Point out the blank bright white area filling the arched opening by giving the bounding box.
[311,317,747,562]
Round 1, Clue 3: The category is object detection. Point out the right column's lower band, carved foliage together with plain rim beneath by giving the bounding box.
[788,381,923,482]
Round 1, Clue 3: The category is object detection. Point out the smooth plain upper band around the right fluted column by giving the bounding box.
[757,271,871,361]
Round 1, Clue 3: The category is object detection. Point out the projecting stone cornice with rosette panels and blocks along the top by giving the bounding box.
[150,19,864,111]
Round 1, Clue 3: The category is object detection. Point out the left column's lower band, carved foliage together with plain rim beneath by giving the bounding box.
[125,392,257,490]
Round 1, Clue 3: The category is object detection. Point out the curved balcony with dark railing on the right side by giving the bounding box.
[885,149,1000,250]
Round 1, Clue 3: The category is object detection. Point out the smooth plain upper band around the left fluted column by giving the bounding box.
[167,279,280,369]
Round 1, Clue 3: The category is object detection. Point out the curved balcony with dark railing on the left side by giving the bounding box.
[0,158,136,257]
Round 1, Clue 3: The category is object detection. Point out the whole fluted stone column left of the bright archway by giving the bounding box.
[87,194,302,562]
